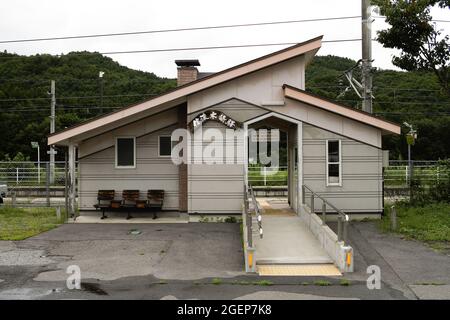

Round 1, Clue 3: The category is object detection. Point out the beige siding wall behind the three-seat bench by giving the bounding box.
[79,124,178,210]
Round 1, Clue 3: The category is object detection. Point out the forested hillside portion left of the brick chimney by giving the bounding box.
[0,52,176,160]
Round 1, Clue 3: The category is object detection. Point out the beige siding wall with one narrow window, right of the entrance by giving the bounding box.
[303,124,382,213]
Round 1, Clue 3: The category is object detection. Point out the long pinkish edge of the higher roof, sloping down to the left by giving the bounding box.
[48,36,322,145]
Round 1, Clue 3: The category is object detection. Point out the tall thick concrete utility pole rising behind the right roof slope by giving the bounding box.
[361,0,372,113]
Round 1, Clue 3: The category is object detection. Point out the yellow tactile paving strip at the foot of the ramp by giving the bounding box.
[257,264,342,276]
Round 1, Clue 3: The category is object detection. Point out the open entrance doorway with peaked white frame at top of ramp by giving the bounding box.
[244,112,302,215]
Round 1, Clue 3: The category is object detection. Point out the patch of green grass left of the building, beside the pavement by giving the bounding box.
[0,207,64,240]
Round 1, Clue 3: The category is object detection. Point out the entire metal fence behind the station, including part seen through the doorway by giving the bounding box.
[0,161,449,206]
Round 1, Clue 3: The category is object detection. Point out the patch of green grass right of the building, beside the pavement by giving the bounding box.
[379,203,450,248]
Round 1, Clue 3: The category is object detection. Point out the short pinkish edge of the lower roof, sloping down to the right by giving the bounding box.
[283,84,401,134]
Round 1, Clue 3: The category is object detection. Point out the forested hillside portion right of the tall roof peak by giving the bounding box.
[306,56,450,160]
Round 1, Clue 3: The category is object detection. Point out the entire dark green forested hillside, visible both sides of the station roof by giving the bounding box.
[0,52,450,160]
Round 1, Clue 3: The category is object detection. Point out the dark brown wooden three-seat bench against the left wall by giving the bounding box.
[94,190,164,220]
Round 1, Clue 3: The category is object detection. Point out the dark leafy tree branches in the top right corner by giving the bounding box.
[372,0,450,95]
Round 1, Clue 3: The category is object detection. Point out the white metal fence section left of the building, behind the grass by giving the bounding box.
[0,161,76,206]
